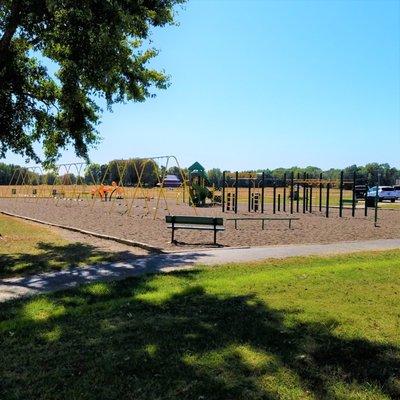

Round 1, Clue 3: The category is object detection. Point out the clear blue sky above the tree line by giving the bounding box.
[7,0,400,170]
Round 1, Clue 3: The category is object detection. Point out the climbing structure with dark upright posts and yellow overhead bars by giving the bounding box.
[221,171,377,222]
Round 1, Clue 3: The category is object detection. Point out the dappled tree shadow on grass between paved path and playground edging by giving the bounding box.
[0,242,138,278]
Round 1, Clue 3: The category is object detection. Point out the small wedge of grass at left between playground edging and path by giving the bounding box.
[0,215,118,278]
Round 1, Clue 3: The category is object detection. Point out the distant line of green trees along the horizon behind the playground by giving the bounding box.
[0,159,400,188]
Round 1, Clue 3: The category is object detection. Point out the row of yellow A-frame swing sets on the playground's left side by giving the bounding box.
[0,156,196,219]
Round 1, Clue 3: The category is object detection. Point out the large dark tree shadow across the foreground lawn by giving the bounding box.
[0,276,400,400]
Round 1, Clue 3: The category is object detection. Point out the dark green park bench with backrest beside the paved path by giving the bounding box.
[165,215,225,244]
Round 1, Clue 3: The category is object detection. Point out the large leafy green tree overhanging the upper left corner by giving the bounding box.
[0,0,183,162]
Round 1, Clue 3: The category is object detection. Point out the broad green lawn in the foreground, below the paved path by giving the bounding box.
[0,251,400,400]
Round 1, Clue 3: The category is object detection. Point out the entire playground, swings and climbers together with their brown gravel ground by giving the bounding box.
[0,156,400,250]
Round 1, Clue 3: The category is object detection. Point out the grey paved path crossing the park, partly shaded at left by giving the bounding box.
[0,239,400,302]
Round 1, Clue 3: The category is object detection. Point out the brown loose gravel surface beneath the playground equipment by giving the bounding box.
[0,198,400,250]
